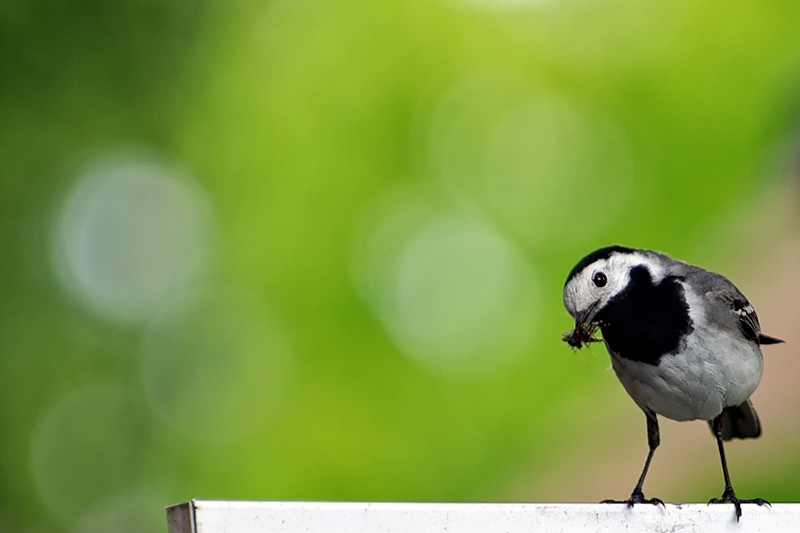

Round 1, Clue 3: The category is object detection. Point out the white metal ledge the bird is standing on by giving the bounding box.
[167,500,800,533]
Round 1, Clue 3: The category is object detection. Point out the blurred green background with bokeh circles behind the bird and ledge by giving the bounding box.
[0,0,800,533]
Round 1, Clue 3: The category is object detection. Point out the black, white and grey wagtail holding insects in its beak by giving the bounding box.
[563,246,783,520]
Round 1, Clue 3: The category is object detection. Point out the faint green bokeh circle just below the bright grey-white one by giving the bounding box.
[141,289,290,442]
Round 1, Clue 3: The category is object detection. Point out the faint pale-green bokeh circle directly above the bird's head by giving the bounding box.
[483,98,633,246]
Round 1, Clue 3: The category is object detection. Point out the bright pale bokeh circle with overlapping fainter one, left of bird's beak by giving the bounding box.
[355,191,536,376]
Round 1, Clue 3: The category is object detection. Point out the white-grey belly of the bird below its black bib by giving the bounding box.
[606,330,763,420]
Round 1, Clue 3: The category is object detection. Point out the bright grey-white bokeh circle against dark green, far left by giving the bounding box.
[52,152,212,322]
